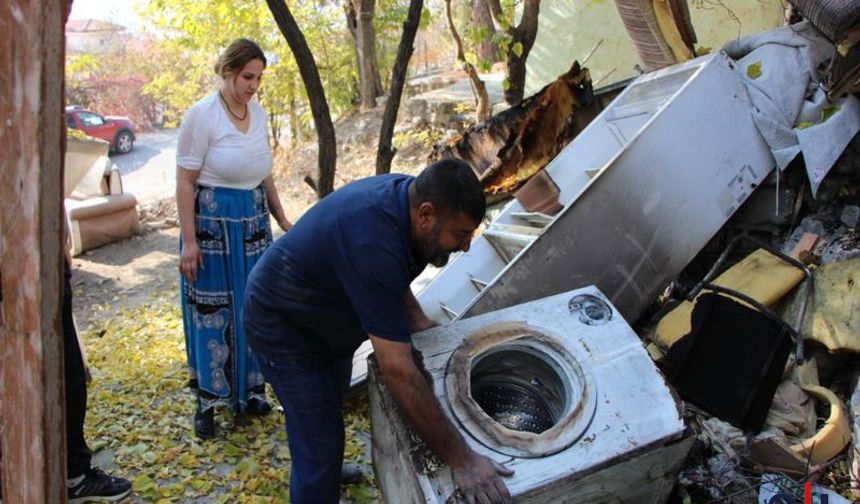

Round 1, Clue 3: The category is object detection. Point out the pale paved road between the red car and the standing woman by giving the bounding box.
[111,129,179,205]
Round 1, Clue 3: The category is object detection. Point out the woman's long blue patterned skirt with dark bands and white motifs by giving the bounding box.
[179,186,272,412]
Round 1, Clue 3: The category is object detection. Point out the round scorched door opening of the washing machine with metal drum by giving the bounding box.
[445,323,596,458]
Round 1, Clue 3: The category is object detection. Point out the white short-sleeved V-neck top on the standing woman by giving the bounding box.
[176,92,272,189]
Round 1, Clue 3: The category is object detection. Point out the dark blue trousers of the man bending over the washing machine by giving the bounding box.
[244,298,352,504]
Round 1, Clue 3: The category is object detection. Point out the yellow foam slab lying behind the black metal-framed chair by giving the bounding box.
[656,249,803,348]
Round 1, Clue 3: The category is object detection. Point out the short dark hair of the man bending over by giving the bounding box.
[414,158,487,224]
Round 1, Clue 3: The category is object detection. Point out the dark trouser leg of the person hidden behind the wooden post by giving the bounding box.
[62,262,92,478]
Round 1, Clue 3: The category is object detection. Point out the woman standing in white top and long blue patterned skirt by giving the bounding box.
[176,39,292,438]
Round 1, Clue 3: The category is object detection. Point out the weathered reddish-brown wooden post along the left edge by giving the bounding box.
[0,0,70,504]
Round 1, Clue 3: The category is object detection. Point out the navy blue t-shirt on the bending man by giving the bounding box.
[248,174,426,355]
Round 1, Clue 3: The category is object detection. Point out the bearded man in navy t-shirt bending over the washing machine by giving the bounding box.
[244,159,512,504]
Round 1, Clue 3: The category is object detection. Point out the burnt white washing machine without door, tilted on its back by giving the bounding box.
[368,287,692,504]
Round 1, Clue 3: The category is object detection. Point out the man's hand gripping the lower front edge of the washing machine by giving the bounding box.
[452,452,514,504]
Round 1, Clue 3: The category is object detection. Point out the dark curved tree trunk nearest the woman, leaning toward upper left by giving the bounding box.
[266,0,337,198]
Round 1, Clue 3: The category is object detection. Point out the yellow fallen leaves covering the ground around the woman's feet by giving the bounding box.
[82,291,379,504]
